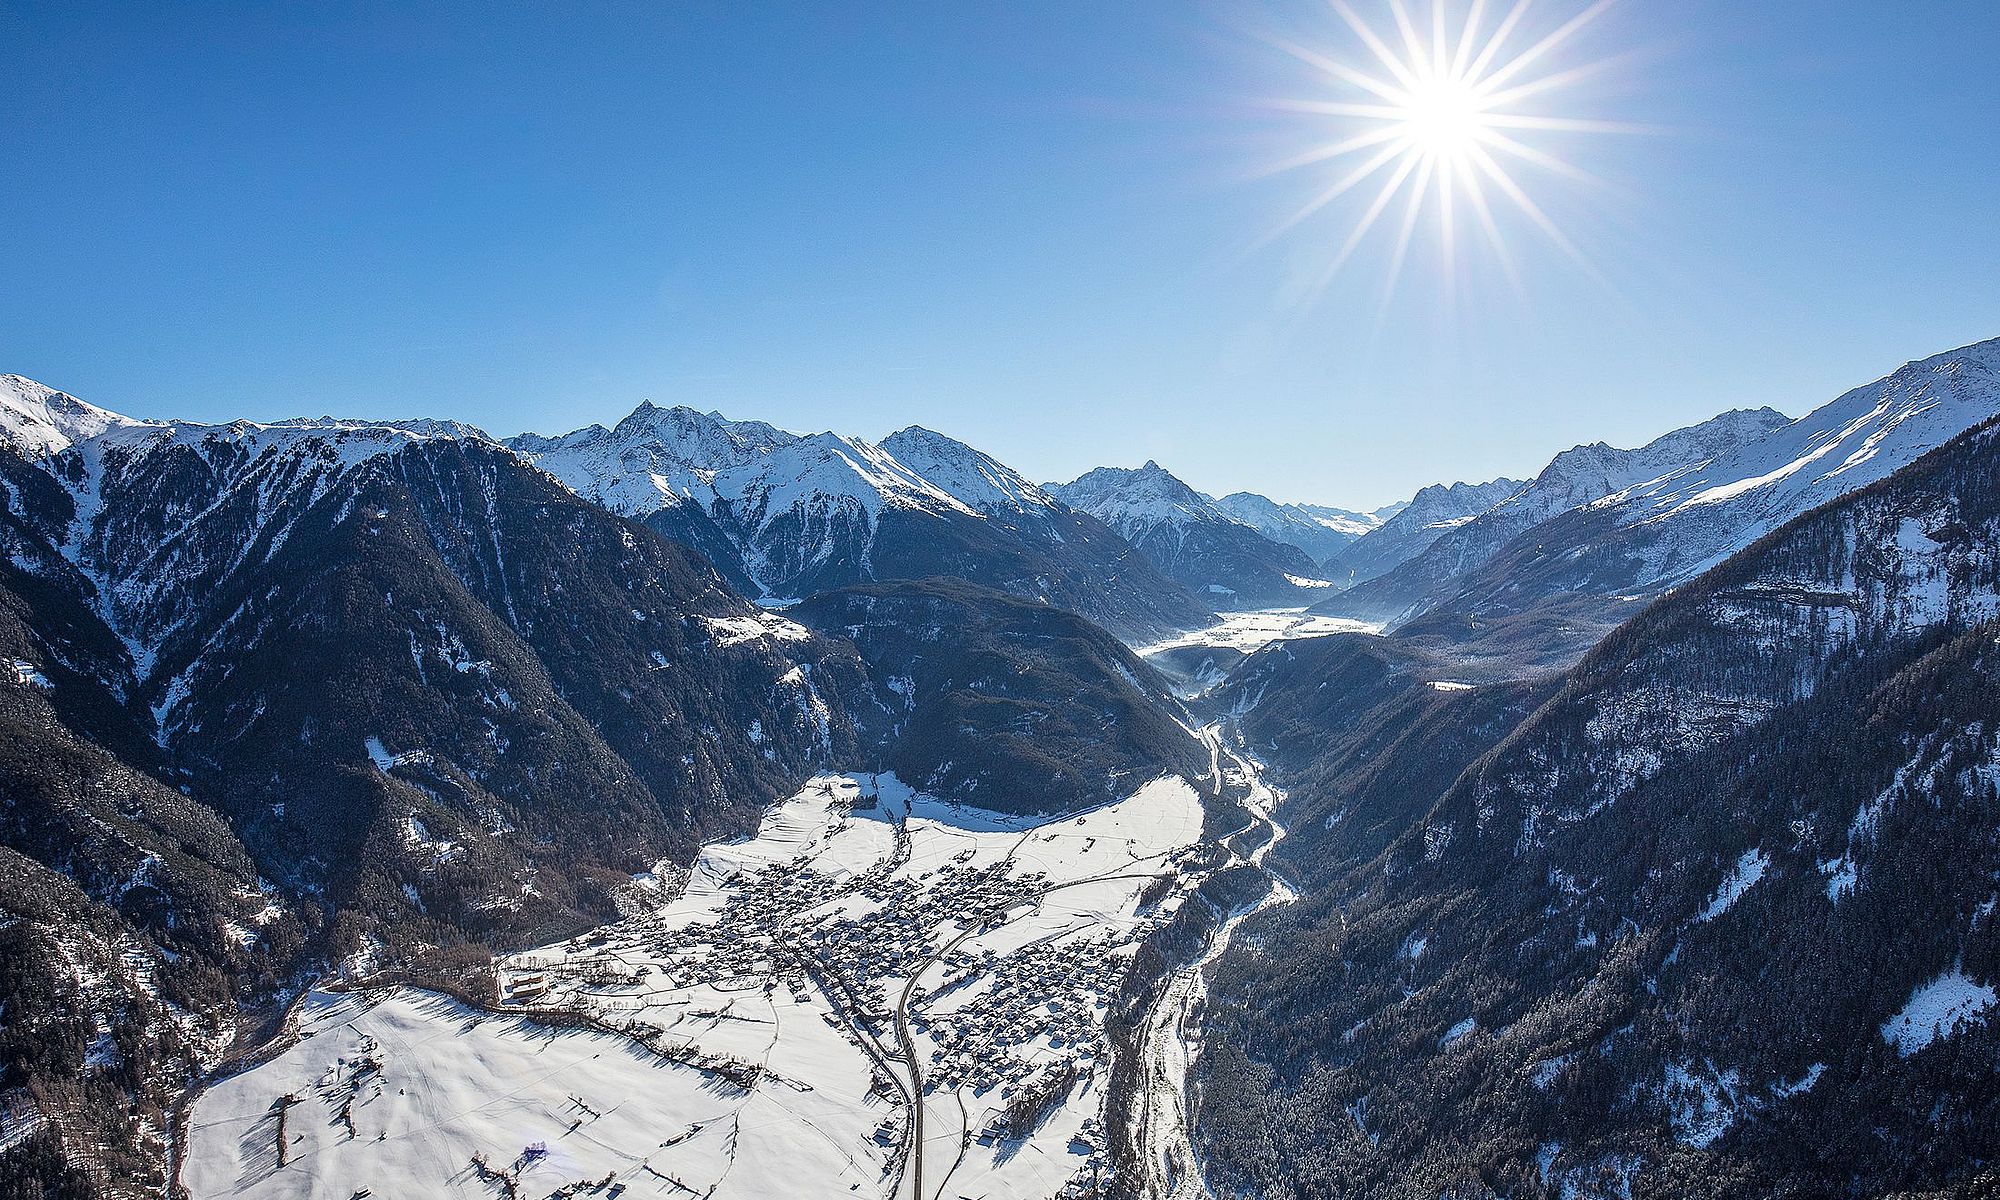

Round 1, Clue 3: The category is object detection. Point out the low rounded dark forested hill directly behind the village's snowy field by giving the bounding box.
[792,580,1208,812]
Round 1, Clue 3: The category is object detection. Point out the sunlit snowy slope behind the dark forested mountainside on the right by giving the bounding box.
[1328,340,2000,676]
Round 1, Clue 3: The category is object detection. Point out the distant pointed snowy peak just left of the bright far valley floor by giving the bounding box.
[1048,462,1318,608]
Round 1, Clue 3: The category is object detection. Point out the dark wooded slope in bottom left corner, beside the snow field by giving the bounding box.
[0,680,296,1196]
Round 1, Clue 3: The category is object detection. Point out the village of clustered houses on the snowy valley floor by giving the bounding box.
[500,776,1188,1184]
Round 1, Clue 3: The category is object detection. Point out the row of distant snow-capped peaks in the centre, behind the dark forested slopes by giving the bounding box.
[508,404,1402,620]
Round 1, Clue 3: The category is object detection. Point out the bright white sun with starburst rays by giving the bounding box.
[1266,0,1638,304]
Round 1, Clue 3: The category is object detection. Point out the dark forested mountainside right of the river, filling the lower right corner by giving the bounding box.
[1198,426,2000,1196]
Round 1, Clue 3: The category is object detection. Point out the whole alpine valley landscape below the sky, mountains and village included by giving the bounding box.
[0,330,2000,1200]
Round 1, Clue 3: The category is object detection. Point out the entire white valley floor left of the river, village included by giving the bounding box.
[182,776,1202,1200]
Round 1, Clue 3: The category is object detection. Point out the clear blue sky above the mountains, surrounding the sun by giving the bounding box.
[0,0,2000,504]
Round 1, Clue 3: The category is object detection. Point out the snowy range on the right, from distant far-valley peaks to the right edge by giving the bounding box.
[1322,340,2000,656]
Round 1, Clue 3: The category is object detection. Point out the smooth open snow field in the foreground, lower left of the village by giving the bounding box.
[182,990,884,1198]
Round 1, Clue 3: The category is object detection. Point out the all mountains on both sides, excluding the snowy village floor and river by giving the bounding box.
[11,330,2000,1198]
